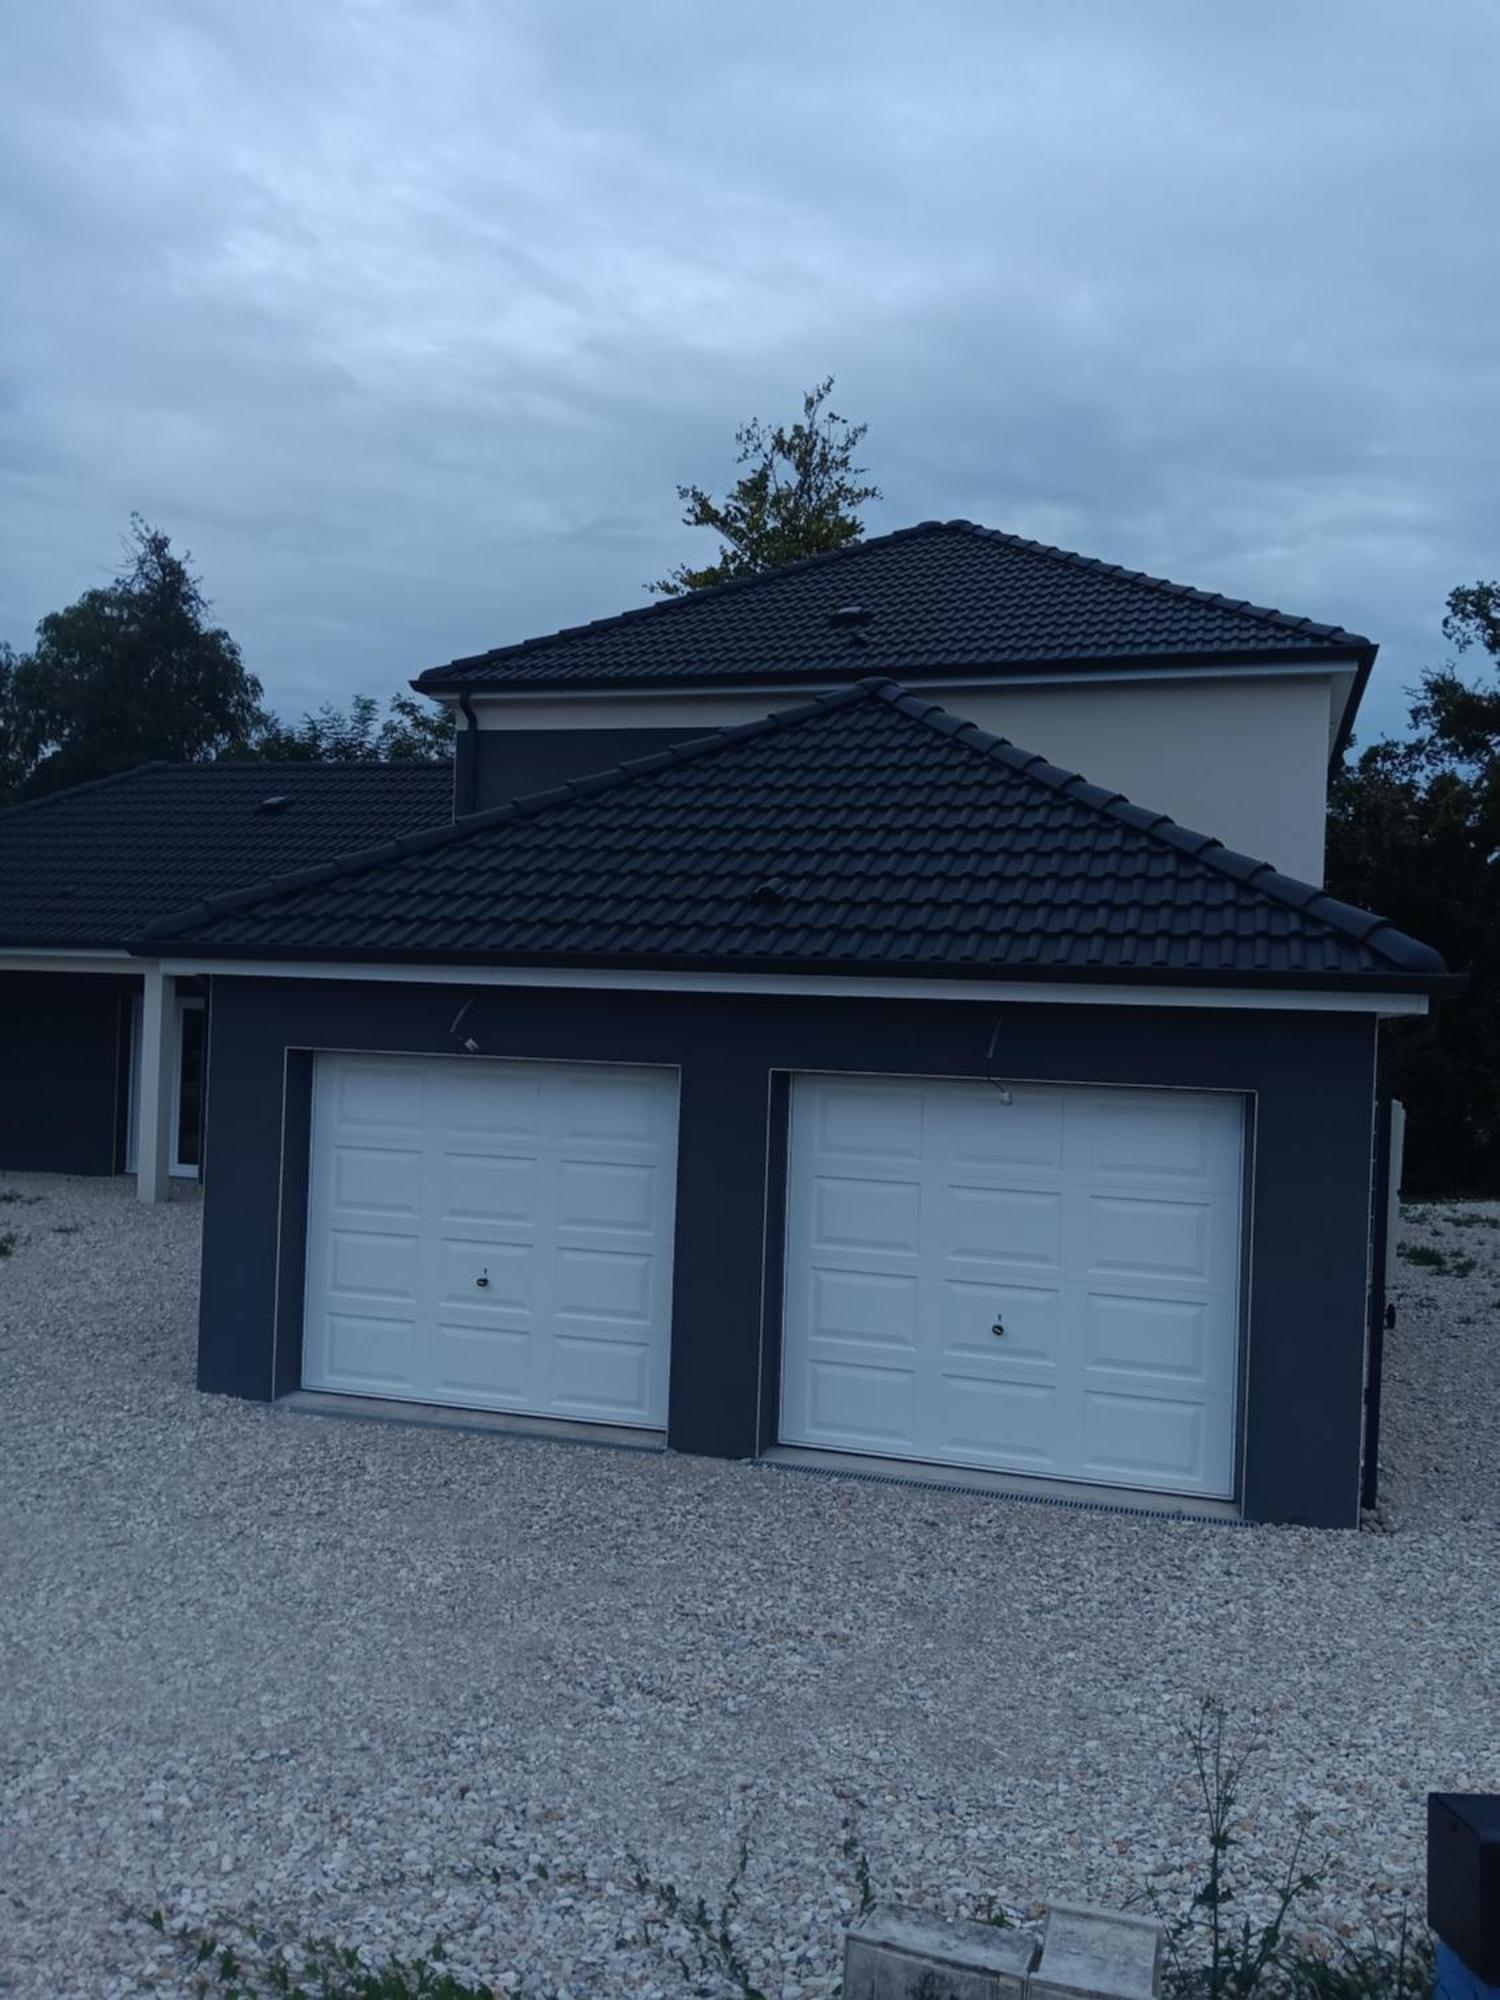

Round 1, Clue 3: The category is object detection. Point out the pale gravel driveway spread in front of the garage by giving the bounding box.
[0,1176,1500,2000]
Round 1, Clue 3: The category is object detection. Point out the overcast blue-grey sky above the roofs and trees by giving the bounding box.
[0,0,1500,748]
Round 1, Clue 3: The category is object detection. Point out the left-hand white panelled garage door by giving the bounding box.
[302,1056,676,1428]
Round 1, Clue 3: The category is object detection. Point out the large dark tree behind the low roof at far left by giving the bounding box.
[0,514,262,796]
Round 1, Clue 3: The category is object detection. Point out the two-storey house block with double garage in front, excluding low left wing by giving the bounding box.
[136,522,1450,1526]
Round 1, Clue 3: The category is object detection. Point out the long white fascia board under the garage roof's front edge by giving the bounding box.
[162,958,1428,1014]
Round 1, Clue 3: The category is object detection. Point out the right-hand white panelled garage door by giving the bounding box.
[782,1076,1244,1496]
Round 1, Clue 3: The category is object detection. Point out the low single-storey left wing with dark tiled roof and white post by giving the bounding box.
[0,764,452,1198]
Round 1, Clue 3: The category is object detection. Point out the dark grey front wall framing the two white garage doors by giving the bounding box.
[198,978,1374,1526]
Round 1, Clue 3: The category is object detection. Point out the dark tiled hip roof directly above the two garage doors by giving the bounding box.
[142,682,1444,986]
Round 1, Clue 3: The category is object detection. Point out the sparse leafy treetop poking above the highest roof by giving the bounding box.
[648,376,880,598]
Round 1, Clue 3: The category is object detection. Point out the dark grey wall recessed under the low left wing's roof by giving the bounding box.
[0,972,140,1174]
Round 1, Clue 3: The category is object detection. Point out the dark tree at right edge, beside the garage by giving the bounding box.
[1328,584,1500,1194]
